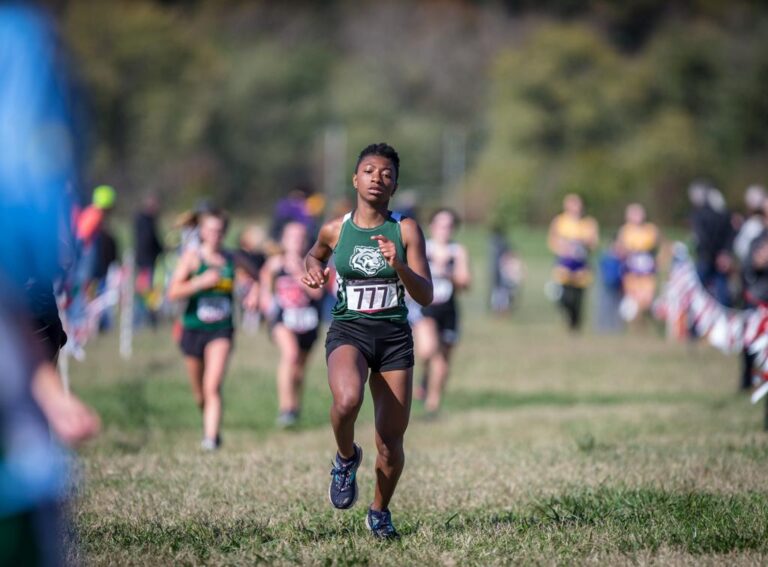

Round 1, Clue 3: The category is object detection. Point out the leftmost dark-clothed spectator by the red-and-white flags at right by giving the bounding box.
[688,181,734,307]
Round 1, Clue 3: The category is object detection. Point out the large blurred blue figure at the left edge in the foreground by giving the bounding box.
[0,4,99,565]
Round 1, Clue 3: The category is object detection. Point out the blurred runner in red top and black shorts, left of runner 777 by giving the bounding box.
[261,222,323,427]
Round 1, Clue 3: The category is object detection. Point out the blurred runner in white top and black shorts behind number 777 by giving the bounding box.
[413,209,471,414]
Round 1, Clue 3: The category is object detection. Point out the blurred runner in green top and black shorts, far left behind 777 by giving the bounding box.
[168,211,259,451]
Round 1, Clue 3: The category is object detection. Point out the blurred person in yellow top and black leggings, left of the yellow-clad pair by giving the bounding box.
[547,194,599,331]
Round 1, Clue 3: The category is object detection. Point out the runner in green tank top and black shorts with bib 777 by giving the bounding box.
[302,144,432,539]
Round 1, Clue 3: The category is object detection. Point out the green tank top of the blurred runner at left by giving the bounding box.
[182,253,235,331]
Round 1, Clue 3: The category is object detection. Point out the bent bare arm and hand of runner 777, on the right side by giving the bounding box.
[371,219,432,305]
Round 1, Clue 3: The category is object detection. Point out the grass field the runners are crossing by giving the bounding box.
[67,232,768,565]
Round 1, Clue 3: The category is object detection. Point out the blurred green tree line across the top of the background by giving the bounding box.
[62,0,768,226]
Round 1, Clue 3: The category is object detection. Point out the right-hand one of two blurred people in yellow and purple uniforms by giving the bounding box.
[617,203,659,321]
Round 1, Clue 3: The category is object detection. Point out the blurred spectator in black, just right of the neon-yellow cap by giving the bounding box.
[133,194,163,327]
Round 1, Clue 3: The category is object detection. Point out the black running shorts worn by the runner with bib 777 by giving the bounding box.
[325,318,413,372]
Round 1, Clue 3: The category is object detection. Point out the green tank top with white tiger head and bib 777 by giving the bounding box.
[331,213,408,323]
